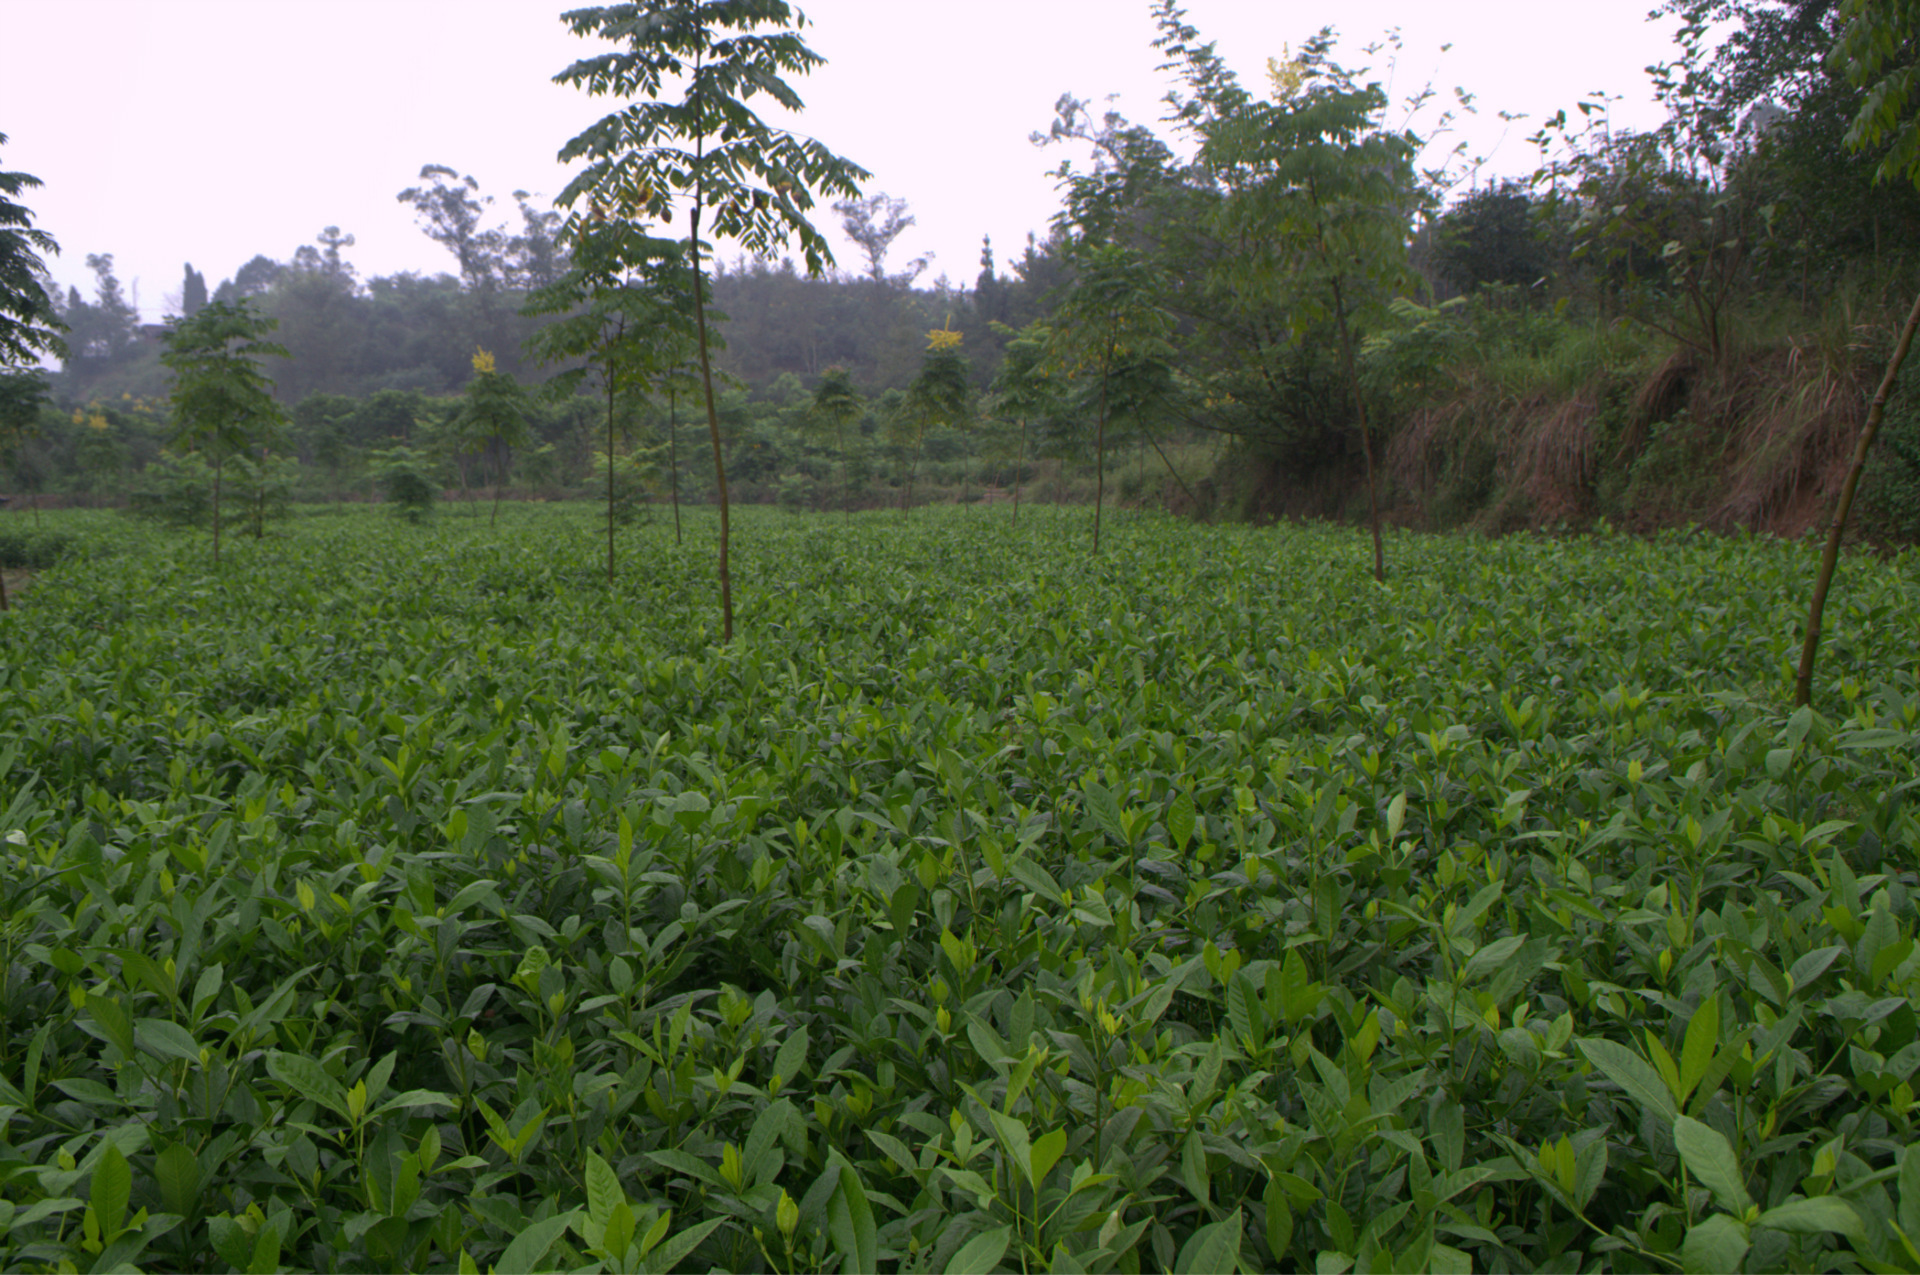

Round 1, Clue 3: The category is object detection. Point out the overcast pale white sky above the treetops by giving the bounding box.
[0,0,1670,321]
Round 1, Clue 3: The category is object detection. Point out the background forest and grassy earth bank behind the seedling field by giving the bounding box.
[11,0,1920,540]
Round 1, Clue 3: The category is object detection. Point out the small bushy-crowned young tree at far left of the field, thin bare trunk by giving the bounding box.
[159,300,286,566]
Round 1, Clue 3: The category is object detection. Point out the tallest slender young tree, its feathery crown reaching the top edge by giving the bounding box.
[555,0,868,641]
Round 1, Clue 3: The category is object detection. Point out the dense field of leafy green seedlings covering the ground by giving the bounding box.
[0,507,1920,1271]
